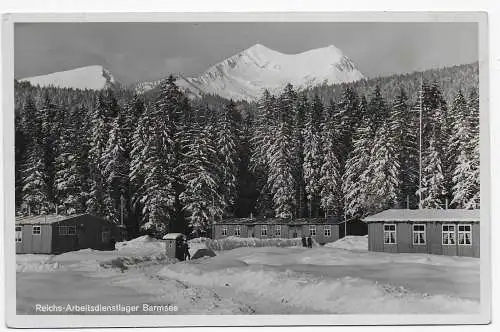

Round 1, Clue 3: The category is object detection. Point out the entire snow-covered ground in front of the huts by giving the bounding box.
[17,236,479,314]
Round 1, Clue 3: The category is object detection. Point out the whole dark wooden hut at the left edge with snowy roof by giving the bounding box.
[15,214,119,254]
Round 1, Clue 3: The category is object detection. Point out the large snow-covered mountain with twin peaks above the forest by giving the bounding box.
[137,44,364,100]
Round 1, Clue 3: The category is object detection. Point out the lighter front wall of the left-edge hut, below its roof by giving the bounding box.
[16,224,52,254]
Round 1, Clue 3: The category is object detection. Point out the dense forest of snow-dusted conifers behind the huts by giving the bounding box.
[15,63,480,236]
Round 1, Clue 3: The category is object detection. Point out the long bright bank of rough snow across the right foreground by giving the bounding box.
[158,260,479,314]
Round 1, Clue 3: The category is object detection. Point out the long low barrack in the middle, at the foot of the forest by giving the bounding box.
[212,217,344,244]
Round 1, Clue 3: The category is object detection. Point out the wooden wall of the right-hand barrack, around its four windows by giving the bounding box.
[368,222,480,257]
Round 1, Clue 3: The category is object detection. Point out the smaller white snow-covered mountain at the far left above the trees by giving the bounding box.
[19,66,116,90]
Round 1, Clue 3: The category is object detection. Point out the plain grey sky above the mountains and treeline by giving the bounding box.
[14,22,478,84]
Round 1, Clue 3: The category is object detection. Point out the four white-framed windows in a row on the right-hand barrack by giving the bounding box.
[384,224,472,245]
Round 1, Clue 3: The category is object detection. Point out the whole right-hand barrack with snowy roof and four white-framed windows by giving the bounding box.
[364,209,480,257]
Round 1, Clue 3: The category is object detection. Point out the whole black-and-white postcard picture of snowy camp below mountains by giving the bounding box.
[0,13,490,325]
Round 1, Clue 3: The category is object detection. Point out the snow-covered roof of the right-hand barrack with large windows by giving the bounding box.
[363,209,480,223]
